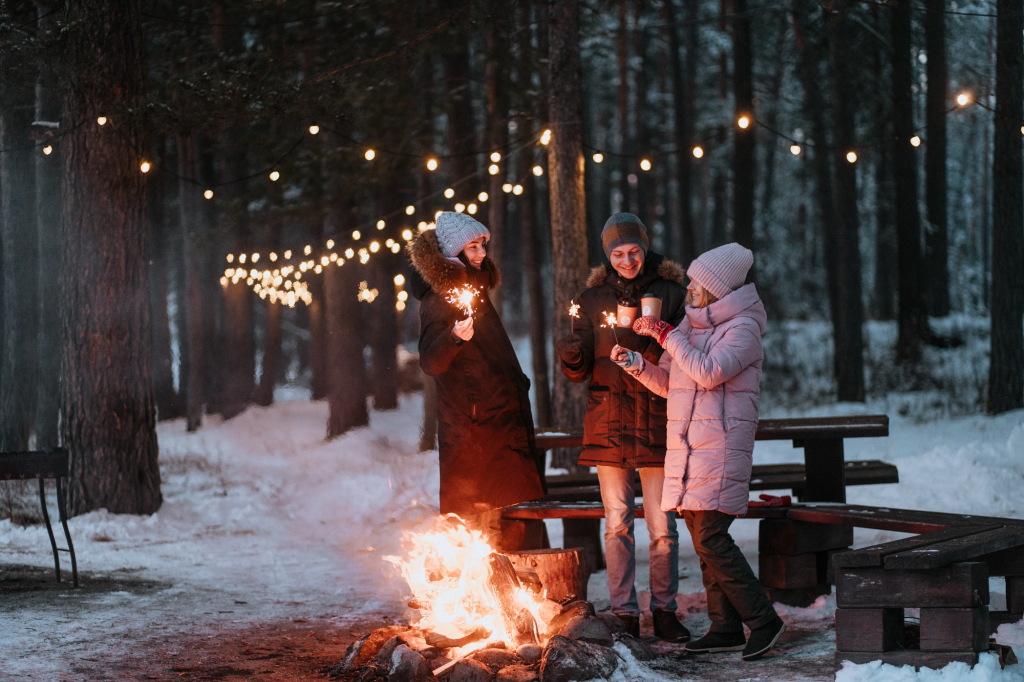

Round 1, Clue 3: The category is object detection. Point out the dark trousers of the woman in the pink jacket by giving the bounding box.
[683,510,778,633]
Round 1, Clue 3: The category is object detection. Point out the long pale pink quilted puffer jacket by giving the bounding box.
[637,284,768,515]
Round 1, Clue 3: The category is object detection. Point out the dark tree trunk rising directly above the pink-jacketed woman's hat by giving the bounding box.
[732,0,756,250]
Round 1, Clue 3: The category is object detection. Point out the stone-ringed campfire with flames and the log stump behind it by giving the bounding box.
[331,515,654,682]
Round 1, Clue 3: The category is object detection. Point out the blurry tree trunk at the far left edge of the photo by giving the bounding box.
[0,59,38,452]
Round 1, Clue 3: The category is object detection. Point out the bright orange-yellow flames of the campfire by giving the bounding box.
[384,514,546,656]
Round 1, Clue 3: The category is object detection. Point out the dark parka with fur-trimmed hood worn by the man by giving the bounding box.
[561,253,686,469]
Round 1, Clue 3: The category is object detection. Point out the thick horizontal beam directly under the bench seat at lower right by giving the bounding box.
[836,562,988,608]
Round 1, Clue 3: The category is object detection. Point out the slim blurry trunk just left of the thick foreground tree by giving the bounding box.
[35,1,61,449]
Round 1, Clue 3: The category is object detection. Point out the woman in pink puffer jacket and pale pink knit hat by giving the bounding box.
[611,244,785,660]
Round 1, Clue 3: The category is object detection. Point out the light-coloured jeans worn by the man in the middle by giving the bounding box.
[597,466,679,615]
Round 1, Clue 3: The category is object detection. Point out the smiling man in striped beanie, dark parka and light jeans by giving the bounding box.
[555,213,690,642]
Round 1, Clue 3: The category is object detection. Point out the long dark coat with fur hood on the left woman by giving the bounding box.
[409,229,545,516]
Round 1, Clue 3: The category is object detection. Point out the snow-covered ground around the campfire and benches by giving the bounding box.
[0,319,1024,682]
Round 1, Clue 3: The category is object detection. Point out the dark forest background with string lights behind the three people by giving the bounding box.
[0,0,1024,515]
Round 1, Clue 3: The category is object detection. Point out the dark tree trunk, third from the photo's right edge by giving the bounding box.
[892,0,927,363]
